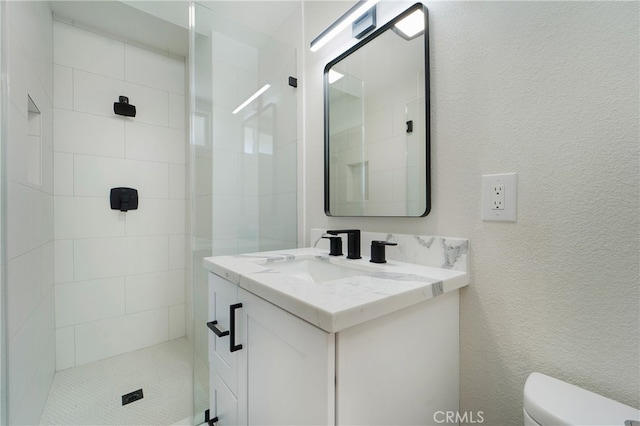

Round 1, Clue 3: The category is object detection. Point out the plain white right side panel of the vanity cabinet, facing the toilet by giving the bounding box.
[336,291,458,426]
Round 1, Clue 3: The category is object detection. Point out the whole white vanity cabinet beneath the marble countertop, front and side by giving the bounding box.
[209,273,458,426]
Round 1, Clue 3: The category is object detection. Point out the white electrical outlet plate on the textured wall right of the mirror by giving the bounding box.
[482,173,518,222]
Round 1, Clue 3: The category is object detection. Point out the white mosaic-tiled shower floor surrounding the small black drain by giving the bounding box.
[40,338,193,425]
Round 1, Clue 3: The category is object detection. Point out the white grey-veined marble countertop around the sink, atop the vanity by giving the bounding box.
[203,248,469,332]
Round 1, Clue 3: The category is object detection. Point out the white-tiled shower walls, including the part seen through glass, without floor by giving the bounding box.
[1,2,299,424]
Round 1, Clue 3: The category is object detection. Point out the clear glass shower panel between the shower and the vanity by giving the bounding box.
[188,2,299,424]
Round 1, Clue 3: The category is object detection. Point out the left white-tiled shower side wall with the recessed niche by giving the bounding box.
[3,2,55,425]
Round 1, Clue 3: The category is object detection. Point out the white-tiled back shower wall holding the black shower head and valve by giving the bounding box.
[53,21,187,370]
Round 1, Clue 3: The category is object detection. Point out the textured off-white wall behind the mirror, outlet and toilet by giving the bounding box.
[304,2,640,425]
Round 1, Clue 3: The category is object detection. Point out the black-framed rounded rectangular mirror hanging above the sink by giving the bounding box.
[324,3,431,217]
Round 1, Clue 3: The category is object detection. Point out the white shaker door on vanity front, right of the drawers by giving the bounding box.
[238,289,335,425]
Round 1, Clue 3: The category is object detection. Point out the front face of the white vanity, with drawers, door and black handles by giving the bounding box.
[209,274,335,426]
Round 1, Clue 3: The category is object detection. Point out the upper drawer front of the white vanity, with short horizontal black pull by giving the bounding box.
[209,274,239,396]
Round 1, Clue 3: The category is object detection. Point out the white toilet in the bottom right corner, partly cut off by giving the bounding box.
[523,373,640,426]
